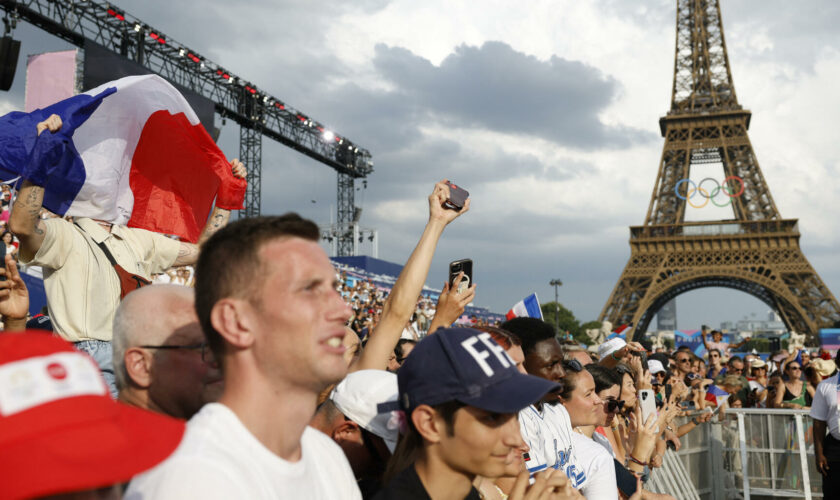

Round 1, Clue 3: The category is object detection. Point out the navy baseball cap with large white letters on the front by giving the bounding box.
[397,328,560,415]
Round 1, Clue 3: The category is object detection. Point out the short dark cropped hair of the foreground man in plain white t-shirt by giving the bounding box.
[195,213,320,363]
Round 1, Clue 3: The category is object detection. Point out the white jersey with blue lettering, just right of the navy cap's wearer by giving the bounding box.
[519,404,587,489]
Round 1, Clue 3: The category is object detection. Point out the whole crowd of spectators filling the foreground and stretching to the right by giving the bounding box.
[0,112,840,500]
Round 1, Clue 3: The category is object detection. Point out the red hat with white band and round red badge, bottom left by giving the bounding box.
[0,331,185,499]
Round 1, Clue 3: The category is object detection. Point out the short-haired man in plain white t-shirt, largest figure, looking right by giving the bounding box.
[126,214,361,500]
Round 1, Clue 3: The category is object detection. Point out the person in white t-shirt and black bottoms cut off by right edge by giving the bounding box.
[811,350,840,498]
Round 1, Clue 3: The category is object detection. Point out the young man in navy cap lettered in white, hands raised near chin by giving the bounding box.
[375,328,567,500]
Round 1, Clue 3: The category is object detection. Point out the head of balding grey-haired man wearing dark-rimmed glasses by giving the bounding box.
[113,285,224,420]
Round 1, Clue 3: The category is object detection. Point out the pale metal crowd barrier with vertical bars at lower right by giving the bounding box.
[648,408,823,500]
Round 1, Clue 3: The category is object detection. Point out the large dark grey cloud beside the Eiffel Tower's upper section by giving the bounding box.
[373,42,653,149]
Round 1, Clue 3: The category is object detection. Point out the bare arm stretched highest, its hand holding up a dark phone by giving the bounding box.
[357,179,470,370]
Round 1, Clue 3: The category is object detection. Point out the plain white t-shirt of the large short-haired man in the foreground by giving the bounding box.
[124,403,362,500]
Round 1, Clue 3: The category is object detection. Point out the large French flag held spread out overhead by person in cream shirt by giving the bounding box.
[0,75,246,242]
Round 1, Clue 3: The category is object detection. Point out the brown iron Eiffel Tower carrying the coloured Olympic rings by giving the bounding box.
[600,0,840,340]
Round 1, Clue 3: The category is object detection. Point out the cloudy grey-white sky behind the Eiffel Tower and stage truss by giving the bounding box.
[0,0,840,329]
